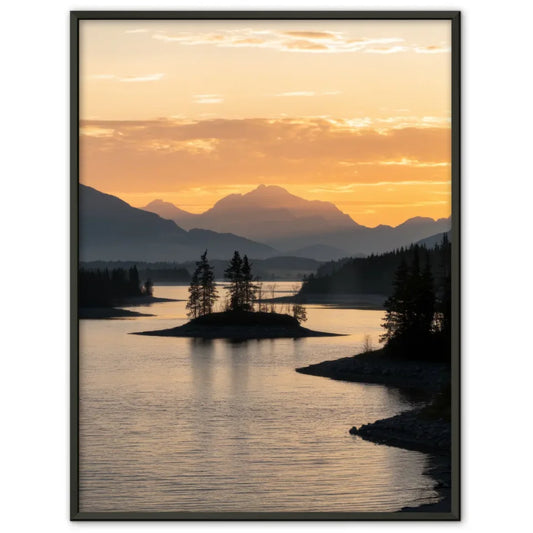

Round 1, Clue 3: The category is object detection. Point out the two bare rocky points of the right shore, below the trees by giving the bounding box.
[296,350,451,513]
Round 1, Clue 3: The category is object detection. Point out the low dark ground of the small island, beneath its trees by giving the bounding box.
[135,311,338,340]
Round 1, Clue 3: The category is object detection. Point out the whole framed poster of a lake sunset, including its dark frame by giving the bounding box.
[71,11,460,520]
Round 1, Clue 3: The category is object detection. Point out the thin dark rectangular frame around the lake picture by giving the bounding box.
[70,11,461,521]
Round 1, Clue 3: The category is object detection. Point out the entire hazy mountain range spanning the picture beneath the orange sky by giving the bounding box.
[79,184,450,262]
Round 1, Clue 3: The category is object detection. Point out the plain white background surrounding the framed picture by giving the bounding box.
[0,0,533,532]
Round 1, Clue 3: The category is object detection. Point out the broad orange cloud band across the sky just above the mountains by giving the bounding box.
[80,115,451,191]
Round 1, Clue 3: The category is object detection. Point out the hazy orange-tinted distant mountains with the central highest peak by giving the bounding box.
[144,185,450,260]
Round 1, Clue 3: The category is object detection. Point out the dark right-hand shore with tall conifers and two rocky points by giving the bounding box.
[296,235,452,511]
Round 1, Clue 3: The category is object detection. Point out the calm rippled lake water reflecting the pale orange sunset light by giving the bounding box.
[80,282,437,511]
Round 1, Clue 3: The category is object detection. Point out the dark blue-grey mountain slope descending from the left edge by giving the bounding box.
[79,185,277,261]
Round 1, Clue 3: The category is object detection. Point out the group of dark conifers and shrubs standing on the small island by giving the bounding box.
[186,250,307,321]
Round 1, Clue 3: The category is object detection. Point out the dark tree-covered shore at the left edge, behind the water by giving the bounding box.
[78,266,153,307]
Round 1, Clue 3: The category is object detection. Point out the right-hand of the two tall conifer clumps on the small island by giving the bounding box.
[224,250,257,311]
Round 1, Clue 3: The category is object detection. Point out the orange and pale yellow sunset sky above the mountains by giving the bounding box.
[80,20,451,226]
